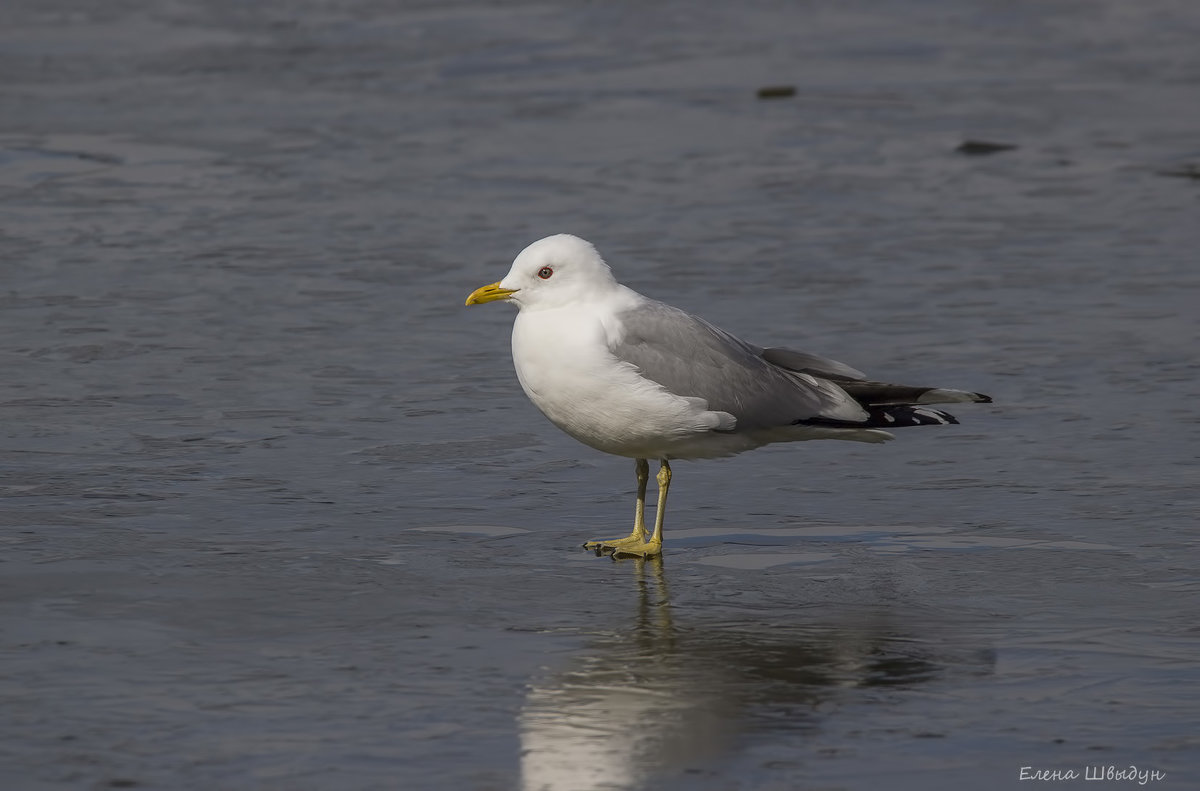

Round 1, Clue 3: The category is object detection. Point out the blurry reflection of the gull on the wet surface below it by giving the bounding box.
[518,557,992,791]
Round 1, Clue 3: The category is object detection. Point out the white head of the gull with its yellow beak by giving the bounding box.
[467,234,617,308]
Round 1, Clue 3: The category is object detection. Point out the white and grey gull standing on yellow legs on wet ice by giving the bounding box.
[467,234,991,558]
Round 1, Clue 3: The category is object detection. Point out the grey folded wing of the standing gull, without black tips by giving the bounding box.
[611,300,866,431]
